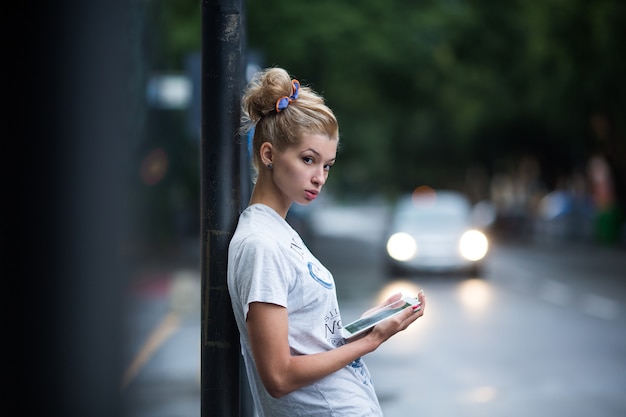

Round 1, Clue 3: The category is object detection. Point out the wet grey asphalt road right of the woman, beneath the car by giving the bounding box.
[314,205,626,417]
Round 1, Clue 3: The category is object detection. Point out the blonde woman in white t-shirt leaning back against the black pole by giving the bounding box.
[228,68,425,417]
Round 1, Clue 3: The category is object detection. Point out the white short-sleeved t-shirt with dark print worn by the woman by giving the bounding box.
[228,204,382,417]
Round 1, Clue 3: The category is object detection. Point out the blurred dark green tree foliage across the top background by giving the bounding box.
[150,0,626,202]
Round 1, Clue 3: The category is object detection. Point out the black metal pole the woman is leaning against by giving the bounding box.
[200,0,243,417]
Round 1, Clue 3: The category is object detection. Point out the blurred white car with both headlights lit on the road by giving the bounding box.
[385,188,489,275]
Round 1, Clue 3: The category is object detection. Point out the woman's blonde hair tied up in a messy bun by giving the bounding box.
[241,68,339,175]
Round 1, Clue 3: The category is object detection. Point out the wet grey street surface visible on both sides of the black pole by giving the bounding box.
[124,203,626,417]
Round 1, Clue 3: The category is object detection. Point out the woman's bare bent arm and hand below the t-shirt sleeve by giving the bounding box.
[247,294,425,398]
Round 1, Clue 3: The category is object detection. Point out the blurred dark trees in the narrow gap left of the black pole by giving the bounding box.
[129,0,202,255]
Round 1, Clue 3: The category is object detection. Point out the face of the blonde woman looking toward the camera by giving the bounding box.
[273,134,337,205]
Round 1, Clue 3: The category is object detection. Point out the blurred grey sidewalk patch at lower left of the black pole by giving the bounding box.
[122,269,201,417]
